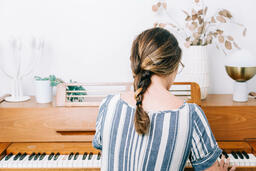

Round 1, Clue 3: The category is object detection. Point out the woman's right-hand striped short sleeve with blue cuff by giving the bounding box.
[190,104,222,170]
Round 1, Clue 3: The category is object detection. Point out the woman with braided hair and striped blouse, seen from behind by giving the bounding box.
[93,28,235,171]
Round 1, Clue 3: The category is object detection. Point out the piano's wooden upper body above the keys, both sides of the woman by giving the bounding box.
[0,94,256,142]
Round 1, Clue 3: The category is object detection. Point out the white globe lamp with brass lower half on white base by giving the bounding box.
[225,49,256,102]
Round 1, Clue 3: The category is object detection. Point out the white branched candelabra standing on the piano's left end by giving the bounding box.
[0,37,44,102]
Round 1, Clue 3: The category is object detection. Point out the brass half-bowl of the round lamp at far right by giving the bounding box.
[225,66,256,82]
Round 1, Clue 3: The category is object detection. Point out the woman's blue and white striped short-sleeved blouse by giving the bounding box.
[93,94,222,171]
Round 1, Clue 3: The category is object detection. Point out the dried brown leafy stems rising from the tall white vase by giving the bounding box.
[152,0,247,55]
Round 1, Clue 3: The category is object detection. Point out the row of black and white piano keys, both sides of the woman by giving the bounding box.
[0,151,256,168]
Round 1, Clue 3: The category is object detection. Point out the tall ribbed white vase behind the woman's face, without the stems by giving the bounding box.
[176,46,210,99]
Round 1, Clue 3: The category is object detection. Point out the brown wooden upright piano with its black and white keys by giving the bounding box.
[0,83,256,171]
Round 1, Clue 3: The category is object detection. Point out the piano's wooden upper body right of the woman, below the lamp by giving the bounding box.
[201,94,256,141]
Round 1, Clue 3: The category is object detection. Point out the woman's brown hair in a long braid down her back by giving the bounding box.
[130,28,181,134]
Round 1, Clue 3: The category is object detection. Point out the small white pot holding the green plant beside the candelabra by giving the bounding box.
[35,80,52,103]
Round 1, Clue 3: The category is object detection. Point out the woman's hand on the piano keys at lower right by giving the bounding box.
[205,155,236,171]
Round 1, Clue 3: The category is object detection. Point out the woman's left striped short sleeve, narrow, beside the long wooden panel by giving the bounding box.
[92,95,111,150]
